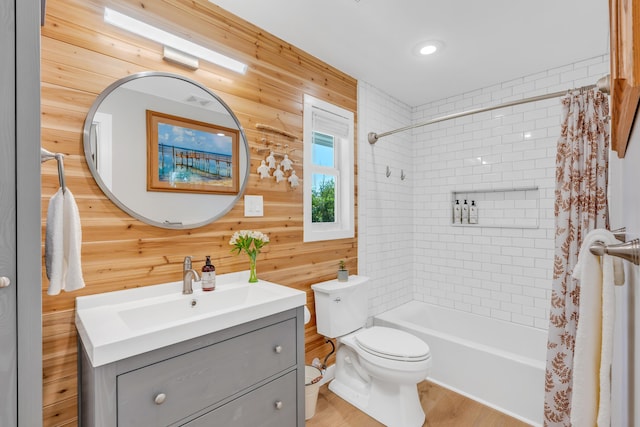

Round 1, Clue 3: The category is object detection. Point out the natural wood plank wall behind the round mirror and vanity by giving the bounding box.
[42,0,357,426]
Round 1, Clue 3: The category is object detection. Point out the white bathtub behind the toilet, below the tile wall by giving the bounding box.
[374,301,547,426]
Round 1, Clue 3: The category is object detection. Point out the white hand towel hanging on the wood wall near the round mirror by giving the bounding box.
[45,189,85,295]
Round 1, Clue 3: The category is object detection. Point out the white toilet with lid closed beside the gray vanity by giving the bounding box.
[311,276,431,427]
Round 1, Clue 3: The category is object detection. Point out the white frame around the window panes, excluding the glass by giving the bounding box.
[303,94,355,242]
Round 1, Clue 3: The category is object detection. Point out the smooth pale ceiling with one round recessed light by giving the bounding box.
[210,0,609,106]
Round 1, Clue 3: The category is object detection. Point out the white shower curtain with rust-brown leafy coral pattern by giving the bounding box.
[544,89,609,427]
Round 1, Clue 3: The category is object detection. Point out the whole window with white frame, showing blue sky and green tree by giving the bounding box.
[303,95,354,242]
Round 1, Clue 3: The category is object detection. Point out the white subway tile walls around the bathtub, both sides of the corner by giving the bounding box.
[358,55,609,329]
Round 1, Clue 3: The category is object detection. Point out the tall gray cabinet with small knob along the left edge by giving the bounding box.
[0,0,42,427]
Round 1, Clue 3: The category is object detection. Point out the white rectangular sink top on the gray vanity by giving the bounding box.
[76,272,306,366]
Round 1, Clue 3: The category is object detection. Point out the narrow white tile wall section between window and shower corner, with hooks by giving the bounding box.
[358,82,415,315]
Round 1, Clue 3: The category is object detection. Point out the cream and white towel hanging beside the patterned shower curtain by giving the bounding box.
[571,229,619,427]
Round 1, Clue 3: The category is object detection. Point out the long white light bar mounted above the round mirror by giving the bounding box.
[104,7,247,74]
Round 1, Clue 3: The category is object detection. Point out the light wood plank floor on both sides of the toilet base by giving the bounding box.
[306,381,528,427]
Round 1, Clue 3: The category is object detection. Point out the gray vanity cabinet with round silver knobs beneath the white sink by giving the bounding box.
[79,308,304,427]
